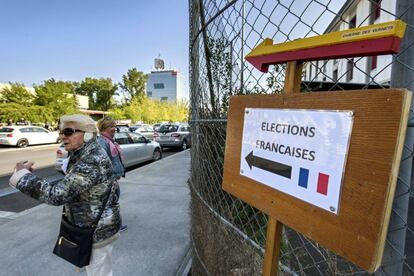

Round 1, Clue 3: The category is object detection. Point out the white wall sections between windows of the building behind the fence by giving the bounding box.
[304,0,396,84]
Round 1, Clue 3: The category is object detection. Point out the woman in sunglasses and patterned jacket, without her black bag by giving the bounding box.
[10,115,121,275]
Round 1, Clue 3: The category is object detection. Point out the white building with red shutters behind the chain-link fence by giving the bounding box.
[304,0,396,85]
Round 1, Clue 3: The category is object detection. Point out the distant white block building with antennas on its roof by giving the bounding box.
[147,70,188,101]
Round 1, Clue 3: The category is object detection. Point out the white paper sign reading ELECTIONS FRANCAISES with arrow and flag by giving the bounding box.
[240,108,353,214]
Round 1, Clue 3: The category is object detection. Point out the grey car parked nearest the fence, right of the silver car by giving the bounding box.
[154,124,191,150]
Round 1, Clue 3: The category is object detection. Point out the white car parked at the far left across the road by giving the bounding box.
[0,125,60,148]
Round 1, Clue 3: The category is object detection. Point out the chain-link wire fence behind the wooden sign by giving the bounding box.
[189,0,414,275]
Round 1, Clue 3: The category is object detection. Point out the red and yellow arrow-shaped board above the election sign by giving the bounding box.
[246,20,406,72]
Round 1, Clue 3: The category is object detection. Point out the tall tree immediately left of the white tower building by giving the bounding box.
[119,68,148,103]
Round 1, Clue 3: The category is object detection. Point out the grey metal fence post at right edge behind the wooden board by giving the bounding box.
[384,0,414,275]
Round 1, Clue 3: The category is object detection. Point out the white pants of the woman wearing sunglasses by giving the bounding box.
[86,244,113,276]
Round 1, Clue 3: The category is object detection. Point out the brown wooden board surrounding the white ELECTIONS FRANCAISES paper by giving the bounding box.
[223,89,411,272]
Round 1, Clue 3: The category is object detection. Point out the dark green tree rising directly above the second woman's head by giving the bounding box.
[75,78,118,111]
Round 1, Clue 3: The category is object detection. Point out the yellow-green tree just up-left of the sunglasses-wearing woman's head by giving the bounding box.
[33,78,77,119]
